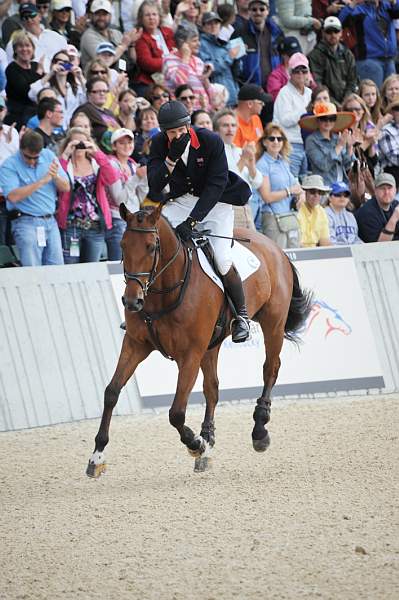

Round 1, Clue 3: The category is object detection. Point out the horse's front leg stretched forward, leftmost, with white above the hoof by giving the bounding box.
[86,334,151,477]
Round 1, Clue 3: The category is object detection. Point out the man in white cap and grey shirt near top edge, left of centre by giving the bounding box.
[80,0,141,68]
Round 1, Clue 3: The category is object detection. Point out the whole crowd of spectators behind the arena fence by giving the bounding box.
[0,0,399,266]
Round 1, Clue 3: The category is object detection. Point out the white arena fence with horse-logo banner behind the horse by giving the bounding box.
[0,242,399,431]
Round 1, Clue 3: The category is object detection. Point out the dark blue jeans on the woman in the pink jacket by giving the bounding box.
[61,225,104,265]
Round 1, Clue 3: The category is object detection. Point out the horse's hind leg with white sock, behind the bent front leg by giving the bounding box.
[194,346,220,471]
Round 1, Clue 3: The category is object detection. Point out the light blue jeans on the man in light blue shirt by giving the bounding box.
[11,216,64,267]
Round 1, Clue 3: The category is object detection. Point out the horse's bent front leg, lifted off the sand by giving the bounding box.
[169,356,205,456]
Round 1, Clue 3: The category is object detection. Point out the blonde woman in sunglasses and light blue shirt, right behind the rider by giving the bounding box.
[253,123,302,248]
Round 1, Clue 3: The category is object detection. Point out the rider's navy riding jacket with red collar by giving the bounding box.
[147,128,251,221]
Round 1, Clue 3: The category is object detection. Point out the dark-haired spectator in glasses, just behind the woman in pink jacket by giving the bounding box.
[74,77,120,152]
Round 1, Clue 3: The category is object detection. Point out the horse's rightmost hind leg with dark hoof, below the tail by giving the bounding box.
[252,308,285,452]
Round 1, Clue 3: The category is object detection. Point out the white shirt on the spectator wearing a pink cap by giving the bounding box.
[273,81,312,144]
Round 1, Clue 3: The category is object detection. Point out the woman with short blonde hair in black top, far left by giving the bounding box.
[6,31,43,129]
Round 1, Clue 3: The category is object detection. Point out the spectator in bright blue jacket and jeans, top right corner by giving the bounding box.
[339,0,399,88]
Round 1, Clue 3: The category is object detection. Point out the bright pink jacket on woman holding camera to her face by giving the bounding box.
[57,150,121,229]
